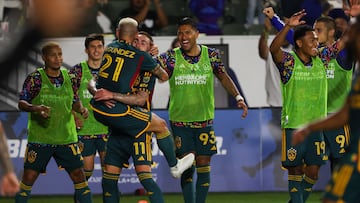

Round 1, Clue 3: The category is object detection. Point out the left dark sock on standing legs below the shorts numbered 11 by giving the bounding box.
[101,171,120,203]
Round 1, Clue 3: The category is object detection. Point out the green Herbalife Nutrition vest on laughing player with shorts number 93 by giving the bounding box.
[169,46,215,122]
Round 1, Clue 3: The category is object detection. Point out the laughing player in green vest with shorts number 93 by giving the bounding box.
[159,17,248,203]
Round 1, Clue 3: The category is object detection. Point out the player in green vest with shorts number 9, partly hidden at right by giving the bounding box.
[264,8,354,171]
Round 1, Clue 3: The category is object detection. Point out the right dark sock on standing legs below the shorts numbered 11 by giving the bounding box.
[137,172,164,203]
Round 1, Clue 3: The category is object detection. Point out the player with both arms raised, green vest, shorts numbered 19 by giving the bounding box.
[270,10,343,203]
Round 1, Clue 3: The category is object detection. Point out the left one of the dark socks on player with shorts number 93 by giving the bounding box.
[181,166,195,203]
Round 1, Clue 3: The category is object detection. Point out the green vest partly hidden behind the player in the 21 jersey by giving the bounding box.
[78,61,108,135]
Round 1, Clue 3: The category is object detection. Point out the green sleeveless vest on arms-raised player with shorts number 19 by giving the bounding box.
[281,52,327,128]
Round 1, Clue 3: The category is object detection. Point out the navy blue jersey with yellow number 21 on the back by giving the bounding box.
[90,41,157,116]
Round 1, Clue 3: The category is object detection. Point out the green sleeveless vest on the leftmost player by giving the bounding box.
[28,68,77,145]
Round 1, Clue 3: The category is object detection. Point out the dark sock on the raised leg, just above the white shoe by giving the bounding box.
[156,131,177,167]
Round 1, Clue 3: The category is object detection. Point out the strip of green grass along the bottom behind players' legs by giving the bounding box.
[0,192,322,203]
